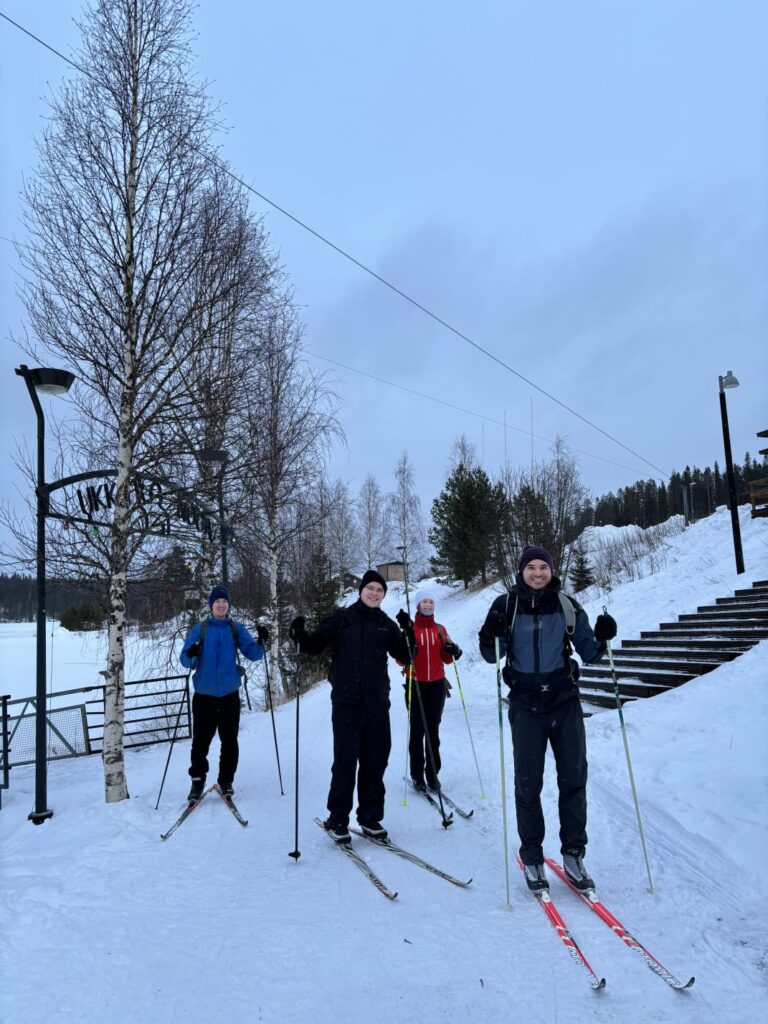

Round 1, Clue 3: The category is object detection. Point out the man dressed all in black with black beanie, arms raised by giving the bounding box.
[290,569,414,843]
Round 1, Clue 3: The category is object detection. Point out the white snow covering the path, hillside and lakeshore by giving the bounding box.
[0,513,768,1024]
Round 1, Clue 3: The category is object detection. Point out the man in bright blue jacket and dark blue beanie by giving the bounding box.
[181,584,269,801]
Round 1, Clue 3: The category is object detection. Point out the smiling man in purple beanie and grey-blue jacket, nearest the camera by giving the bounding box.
[479,546,616,892]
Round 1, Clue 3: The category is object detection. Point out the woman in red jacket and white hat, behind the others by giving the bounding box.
[404,591,462,792]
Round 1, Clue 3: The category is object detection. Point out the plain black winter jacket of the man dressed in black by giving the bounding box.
[300,600,411,708]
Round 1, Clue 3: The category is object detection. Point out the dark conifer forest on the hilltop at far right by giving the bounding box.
[584,452,768,527]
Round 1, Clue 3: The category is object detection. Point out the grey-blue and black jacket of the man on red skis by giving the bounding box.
[478,573,606,711]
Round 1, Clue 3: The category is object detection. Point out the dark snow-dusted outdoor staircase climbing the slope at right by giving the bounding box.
[579,580,768,710]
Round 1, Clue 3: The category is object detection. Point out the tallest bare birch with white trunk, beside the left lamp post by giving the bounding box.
[19,0,252,802]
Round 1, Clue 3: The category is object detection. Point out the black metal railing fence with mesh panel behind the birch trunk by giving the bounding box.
[0,675,191,770]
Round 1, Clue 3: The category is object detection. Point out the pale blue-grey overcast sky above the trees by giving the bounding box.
[0,0,768,548]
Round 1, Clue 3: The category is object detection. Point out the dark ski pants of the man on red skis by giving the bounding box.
[509,697,587,864]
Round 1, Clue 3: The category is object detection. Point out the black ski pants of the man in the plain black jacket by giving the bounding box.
[328,701,392,824]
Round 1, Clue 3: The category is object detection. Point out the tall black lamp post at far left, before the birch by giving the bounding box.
[15,365,75,825]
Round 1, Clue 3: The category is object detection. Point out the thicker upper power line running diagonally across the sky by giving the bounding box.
[0,11,669,478]
